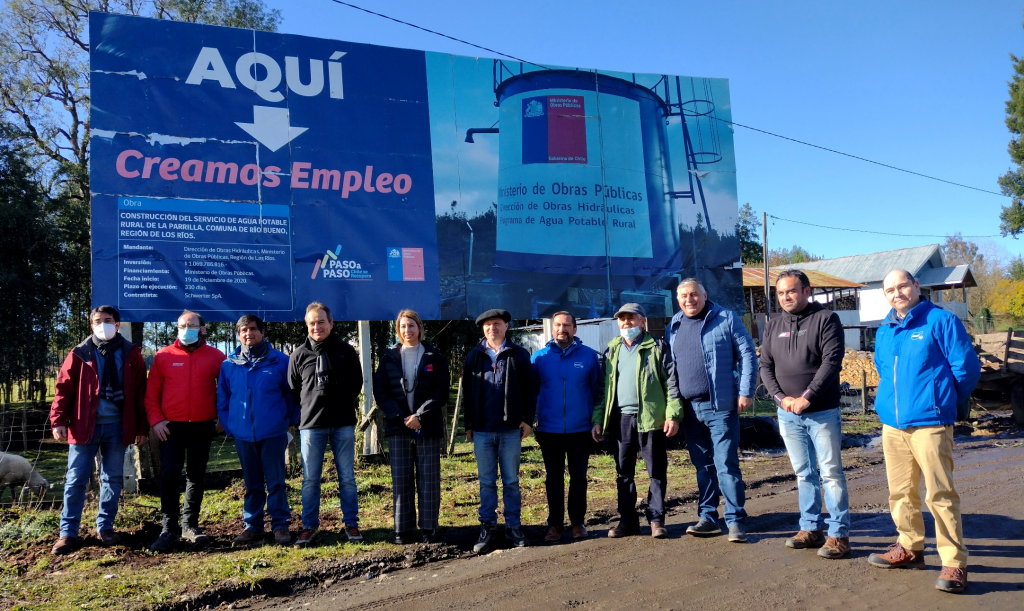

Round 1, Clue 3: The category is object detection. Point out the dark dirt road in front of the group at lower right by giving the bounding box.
[247,438,1024,611]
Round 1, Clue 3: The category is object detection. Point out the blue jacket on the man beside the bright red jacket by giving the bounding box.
[217,347,300,441]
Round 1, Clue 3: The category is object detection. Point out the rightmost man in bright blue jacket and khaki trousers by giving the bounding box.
[867,269,981,594]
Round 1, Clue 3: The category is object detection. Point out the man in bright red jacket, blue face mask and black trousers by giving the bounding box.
[145,310,224,552]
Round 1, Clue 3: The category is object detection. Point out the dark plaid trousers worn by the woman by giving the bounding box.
[387,435,441,532]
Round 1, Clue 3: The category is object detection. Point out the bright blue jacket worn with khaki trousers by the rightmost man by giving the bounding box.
[874,300,981,429]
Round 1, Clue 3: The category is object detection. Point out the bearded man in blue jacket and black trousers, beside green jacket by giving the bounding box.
[530,312,604,543]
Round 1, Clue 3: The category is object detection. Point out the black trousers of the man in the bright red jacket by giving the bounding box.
[160,420,216,531]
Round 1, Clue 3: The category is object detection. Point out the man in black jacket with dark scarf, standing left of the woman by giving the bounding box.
[288,301,362,548]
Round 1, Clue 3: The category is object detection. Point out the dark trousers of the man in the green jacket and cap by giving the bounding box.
[608,413,669,527]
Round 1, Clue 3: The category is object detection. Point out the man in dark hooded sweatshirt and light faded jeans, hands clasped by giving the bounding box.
[761,269,850,559]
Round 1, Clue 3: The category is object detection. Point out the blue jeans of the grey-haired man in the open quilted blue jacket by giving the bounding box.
[682,401,746,524]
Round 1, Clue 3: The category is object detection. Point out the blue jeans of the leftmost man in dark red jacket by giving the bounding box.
[60,422,125,536]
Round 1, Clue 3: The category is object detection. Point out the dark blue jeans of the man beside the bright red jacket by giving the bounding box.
[234,435,292,532]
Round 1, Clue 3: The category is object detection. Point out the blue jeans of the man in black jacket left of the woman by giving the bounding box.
[299,427,359,528]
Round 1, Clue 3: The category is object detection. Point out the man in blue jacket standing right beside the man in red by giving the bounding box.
[217,314,299,545]
